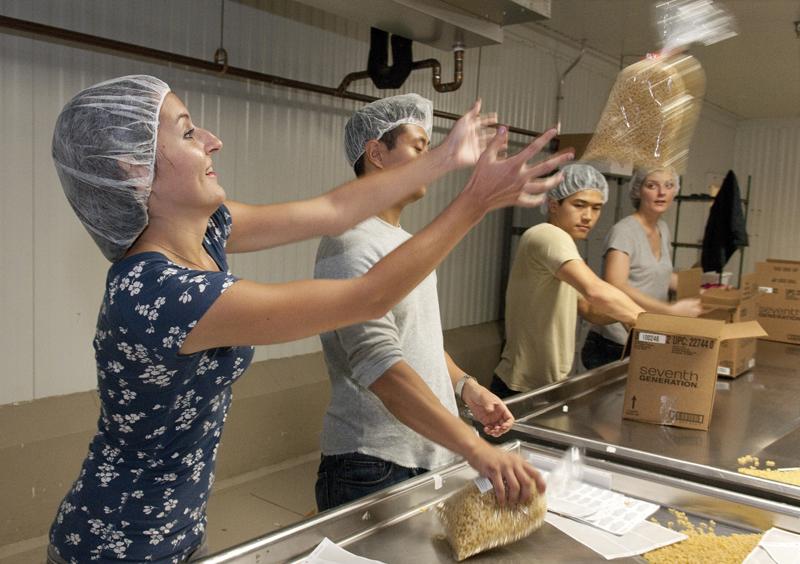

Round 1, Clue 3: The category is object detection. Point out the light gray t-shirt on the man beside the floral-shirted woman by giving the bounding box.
[314,217,458,469]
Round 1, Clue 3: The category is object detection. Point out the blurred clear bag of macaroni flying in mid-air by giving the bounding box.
[582,0,735,173]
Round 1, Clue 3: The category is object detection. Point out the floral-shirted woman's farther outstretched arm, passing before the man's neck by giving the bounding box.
[226,100,496,253]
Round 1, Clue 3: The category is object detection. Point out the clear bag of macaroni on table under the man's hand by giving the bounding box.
[437,478,547,562]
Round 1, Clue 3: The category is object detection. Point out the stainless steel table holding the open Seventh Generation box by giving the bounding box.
[508,341,800,504]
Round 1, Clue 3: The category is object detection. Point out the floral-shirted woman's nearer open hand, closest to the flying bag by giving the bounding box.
[462,126,573,212]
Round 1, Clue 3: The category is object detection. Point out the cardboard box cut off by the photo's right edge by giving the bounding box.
[756,259,800,344]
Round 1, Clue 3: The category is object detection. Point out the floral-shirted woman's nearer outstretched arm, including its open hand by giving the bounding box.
[181,128,571,354]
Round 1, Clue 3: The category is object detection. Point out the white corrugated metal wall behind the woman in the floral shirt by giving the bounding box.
[0,0,744,404]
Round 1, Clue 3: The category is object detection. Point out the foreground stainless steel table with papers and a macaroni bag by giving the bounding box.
[195,441,800,564]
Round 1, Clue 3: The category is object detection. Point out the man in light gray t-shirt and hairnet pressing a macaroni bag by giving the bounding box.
[314,94,535,511]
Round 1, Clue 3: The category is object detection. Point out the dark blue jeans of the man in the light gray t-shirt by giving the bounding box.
[314,452,428,511]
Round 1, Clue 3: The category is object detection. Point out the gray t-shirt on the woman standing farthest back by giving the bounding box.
[592,215,672,345]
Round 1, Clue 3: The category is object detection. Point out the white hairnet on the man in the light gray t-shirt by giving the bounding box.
[344,94,433,166]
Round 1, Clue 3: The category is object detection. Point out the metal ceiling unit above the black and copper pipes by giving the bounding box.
[276,0,551,51]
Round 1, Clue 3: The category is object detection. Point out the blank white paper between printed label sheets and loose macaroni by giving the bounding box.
[545,513,687,560]
